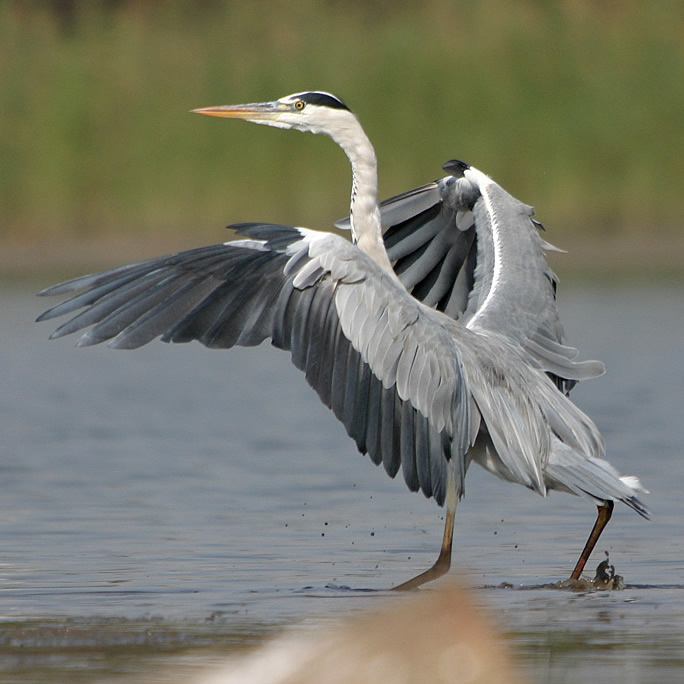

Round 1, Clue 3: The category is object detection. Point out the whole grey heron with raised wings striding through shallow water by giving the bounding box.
[38,91,648,589]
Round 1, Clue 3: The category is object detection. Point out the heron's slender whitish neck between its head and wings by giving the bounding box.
[332,117,396,278]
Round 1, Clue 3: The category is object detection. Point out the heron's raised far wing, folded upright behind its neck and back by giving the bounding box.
[336,160,604,393]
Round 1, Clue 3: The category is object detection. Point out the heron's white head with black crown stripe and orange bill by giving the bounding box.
[193,91,355,137]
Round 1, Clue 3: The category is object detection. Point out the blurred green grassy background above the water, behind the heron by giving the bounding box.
[0,0,684,276]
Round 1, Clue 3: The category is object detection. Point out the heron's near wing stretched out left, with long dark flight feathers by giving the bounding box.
[39,224,478,504]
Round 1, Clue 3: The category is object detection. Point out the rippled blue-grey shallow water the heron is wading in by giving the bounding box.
[0,285,684,684]
